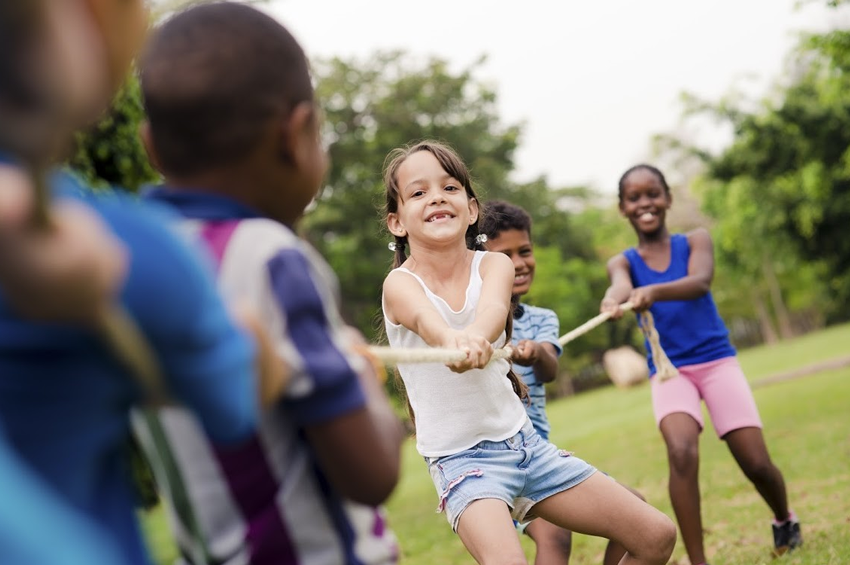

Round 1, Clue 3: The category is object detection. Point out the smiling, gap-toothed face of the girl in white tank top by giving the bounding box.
[387,151,478,246]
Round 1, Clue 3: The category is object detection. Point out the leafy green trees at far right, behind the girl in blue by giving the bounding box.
[648,5,850,333]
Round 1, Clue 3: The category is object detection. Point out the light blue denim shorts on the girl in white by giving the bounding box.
[425,421,596,532]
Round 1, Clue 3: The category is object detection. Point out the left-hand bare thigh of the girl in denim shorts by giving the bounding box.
[457,498,528,565]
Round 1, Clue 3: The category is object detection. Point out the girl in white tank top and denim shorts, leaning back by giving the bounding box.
[382,141,676,565]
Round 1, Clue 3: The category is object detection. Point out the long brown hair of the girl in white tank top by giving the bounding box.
[384,139,528,422]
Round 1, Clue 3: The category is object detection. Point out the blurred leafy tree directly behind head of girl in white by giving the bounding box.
[304,52,520,337]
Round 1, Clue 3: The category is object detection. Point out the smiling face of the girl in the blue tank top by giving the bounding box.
[620,168,672,236]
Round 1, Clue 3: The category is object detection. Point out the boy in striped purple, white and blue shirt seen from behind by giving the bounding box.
[139,2,403,565]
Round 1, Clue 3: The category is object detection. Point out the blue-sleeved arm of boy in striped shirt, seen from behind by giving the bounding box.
[268,249,403,505]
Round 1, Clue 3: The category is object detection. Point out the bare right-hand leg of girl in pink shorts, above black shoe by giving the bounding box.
[723,428,788,522]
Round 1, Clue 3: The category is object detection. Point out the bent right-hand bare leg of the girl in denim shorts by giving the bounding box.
[532,473,676,565]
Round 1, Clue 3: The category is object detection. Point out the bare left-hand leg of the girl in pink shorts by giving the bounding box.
[660,412,705,563]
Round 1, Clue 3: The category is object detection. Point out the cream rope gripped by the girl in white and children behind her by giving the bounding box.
[366,302,679,381]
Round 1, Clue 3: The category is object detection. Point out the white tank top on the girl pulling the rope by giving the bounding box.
[384,251,527,457]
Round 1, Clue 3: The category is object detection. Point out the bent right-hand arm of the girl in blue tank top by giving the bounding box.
[629,228,714,311]
